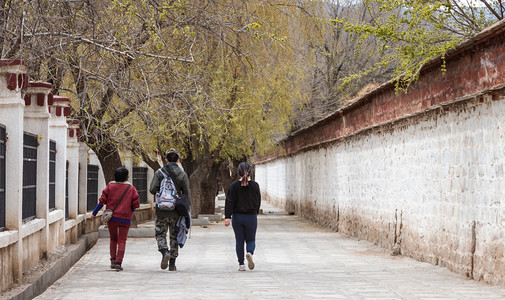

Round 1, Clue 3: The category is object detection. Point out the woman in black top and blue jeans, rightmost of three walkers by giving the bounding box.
[224,162,261,271]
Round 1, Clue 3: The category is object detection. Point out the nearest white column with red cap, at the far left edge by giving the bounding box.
[0,60,28,283]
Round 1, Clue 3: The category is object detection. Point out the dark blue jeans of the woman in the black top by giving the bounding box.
[231,214,258,265]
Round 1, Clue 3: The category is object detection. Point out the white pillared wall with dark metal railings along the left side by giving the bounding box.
[0,59,154,297]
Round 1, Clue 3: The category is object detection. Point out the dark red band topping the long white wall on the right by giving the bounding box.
[255,20,505,164]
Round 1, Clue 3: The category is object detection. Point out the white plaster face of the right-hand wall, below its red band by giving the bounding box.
[256,101,505,282]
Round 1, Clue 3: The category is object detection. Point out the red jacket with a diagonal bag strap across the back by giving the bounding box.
[99,181,140,220]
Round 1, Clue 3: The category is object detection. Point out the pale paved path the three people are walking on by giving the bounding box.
[35,204,505,300]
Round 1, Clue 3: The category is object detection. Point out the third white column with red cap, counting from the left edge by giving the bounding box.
[49,95,70,246]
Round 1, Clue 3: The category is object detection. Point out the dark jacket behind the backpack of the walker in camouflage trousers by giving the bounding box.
[149,163,191,217]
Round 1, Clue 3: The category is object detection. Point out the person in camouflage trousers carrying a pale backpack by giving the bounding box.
[149,148,191,271]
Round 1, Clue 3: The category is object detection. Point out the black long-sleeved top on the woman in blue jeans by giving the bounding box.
[224,180,261,219]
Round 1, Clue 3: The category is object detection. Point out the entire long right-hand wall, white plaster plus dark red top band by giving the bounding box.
[256,22,505,283]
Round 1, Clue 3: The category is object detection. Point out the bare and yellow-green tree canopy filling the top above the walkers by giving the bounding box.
[0,0,504,214]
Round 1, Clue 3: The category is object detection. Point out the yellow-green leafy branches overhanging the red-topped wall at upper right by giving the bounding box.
[330,0,498,91]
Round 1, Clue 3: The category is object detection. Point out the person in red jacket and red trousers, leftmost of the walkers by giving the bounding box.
[91,167,140,271]
